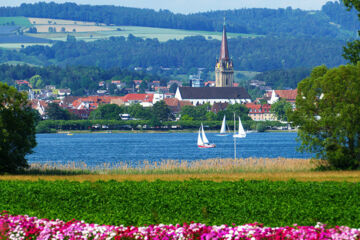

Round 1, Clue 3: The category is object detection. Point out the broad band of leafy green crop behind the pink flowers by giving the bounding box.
[0,180,360,228]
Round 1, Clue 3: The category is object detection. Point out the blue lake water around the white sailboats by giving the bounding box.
[27,132,312,166]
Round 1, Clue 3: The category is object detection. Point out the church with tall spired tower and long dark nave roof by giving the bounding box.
[175,23,251,105]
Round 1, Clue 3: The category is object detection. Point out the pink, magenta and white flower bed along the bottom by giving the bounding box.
[0,214,360,240]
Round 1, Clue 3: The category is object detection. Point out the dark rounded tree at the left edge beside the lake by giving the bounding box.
[0,82,36,173]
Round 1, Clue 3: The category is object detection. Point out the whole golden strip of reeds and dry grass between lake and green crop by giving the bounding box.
[0,158,360,182]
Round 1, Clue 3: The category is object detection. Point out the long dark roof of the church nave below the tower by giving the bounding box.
[179,87,251,99]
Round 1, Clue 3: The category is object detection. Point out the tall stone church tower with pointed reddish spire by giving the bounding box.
[215,21,234,87]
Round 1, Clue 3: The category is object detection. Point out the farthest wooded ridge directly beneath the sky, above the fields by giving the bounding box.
[0,2,359,39]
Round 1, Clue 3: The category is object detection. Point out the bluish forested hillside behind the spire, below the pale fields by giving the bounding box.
[10,35,345,71]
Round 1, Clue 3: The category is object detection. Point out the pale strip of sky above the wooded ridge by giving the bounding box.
[0,0,336,13]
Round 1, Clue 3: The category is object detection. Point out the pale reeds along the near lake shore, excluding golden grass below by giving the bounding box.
[24,158,316,175]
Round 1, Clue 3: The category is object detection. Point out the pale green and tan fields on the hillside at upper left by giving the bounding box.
[0,17,260,49]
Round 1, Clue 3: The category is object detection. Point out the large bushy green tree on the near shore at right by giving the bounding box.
[289,63,360,169]
